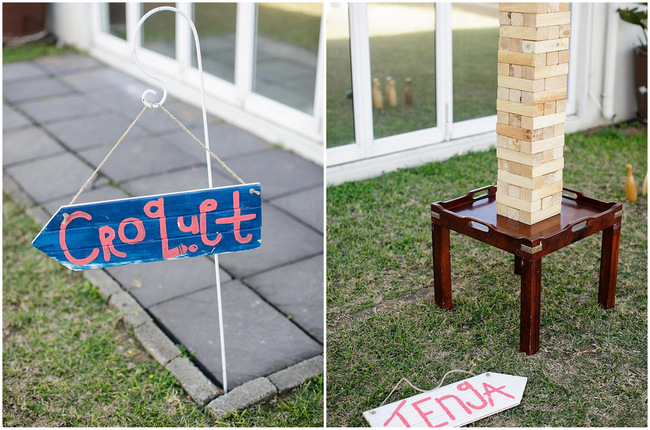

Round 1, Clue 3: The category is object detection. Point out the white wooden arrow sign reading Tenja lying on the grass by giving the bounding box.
[363,373,527,427]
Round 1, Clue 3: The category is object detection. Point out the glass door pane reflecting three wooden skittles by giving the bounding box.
[368,3,436,138]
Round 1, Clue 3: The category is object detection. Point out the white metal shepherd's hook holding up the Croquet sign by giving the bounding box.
[133,6,228,394]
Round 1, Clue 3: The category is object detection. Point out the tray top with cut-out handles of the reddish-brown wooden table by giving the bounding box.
[431,185,622,254]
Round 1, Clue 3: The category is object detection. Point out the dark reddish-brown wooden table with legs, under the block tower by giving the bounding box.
[431,186,623,355]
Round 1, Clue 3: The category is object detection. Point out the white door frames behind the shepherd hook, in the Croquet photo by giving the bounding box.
[90,2,325,165]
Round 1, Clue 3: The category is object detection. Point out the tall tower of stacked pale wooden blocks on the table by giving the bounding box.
[496,3,570,225]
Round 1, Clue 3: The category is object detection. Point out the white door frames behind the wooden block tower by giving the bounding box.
[327,3,580,167]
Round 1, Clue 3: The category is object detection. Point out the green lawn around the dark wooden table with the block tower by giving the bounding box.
[327,125,648,427]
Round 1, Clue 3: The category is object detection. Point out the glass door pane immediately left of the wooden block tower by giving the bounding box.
[451,3,499,122]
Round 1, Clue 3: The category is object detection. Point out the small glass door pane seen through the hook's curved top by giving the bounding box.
[141,3,176,58]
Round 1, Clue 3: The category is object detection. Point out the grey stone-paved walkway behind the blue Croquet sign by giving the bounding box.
[3,55,324,398]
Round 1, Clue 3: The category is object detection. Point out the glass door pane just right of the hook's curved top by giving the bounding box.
[192,3,237,82]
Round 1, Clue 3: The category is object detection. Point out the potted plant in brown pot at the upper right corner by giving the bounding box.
[616,7,648,123]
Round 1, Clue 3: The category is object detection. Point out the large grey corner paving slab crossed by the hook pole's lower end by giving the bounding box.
[149,281,322,387]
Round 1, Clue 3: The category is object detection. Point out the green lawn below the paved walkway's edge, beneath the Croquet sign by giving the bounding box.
[2,195,323,427]
